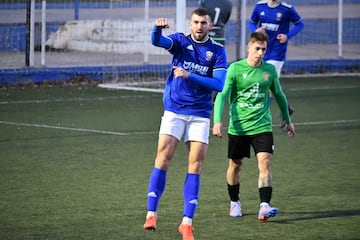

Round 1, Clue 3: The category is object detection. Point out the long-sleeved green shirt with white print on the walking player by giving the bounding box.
[214,59,291,136]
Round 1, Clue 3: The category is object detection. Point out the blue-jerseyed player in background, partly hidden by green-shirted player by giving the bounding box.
[248,0,304,128]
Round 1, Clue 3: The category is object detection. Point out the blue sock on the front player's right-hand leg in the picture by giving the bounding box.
[184,173,200,218]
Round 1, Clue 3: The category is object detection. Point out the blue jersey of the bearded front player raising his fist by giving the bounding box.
[163,33,227,118]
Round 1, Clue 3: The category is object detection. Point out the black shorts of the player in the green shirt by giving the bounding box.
[228,132,274,159]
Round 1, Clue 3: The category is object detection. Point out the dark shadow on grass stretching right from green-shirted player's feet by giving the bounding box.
[271,209,360,224]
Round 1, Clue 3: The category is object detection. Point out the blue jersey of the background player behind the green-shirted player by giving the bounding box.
[249,0,303,61]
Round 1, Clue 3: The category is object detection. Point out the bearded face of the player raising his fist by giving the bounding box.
[189,14,211,41]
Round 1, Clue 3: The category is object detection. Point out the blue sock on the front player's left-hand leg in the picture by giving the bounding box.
[147,167,166,212]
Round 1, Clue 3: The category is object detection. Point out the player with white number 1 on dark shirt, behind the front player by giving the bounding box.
[199,0,232,45]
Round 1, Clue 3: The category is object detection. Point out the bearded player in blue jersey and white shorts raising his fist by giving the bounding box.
[144,8,227,240]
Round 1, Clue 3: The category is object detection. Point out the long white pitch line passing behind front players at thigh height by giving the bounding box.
[0,119,360,136]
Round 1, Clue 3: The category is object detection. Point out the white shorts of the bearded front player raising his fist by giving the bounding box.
[159,111,210,144]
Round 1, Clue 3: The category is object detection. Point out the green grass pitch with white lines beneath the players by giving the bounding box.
[0,77,360,240]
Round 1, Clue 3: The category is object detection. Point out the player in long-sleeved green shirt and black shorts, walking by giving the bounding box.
[213,32,295,221]
